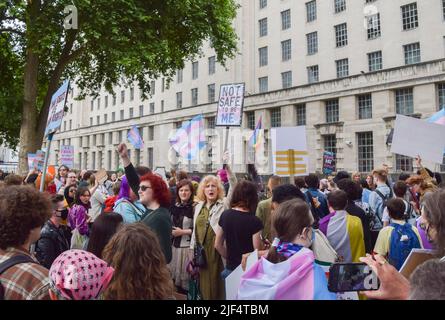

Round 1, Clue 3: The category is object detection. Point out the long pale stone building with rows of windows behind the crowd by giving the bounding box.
[44,0,445,174]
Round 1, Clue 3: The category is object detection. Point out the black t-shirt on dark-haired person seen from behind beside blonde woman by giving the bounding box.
[219,209,263,270]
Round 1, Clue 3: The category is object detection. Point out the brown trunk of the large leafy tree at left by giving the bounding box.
[19,49,41,175]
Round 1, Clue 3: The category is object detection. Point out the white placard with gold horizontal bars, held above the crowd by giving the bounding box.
[271,126,309,177]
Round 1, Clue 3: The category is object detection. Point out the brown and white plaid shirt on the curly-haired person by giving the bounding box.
[0,248,50,300]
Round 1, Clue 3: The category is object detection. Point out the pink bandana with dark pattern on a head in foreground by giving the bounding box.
[49,250,114,300]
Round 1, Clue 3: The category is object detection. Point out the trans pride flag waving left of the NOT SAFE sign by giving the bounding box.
[169,115,206,160]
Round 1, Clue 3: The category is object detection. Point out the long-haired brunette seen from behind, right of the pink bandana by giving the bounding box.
[103,223,174,300]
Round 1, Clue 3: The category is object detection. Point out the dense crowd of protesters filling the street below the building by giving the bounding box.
[0,150,445,300]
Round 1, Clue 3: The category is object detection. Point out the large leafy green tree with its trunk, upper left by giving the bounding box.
[0,0,237,173]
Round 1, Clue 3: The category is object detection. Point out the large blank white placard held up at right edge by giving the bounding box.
[391,115,445,163]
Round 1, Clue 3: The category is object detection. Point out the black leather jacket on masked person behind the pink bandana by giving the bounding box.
[35,220,70,269]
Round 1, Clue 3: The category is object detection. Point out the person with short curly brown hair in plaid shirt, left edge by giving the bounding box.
[0,186,51,300]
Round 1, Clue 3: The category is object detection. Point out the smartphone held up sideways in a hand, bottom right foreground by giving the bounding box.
[328,263,380,292]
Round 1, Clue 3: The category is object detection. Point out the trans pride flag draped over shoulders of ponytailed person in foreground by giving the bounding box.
[237,248,336,300]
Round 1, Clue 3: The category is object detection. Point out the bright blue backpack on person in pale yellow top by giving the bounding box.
[388,223,420,270]
